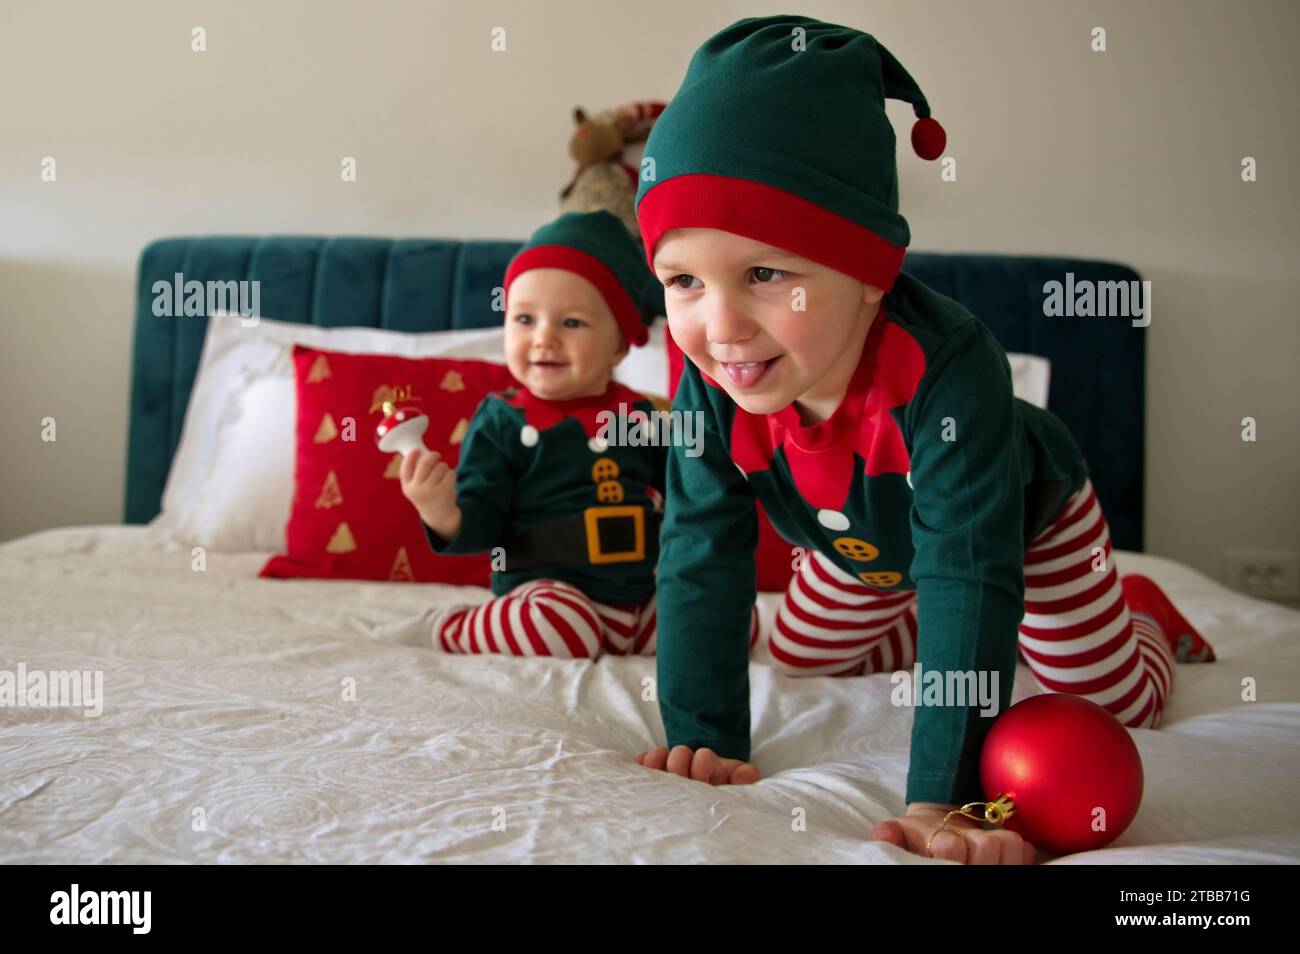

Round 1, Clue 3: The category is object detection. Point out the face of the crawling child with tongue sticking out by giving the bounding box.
[654,229,884,425]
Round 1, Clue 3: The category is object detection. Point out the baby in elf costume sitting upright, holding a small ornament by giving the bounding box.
[400,211,758,658]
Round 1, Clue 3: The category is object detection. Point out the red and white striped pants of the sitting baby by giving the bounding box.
[432,580,758,659]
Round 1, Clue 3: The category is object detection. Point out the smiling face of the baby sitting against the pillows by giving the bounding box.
[506,268,627,400]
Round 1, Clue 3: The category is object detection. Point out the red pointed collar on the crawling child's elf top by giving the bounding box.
[717,304,926,512]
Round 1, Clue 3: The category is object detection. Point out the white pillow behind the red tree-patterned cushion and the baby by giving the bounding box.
[151,315,668,552]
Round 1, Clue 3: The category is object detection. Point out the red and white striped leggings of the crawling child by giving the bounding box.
[770,481,1174,728]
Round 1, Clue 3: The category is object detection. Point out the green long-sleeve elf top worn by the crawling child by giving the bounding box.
[658,273,1087,803]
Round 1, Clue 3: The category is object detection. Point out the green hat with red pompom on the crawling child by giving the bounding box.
[636,16,946,291]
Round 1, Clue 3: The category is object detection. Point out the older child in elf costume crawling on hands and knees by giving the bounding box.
[637,16,1213,863]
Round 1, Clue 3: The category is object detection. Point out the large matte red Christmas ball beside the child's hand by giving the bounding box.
[980,693,1143,854]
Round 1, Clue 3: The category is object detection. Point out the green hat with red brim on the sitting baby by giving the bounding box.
[504,209,650,347]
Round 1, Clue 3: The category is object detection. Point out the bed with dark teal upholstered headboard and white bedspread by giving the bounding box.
[0,237,1300,864]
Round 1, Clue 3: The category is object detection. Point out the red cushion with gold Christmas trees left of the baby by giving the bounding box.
[259,344,515,586]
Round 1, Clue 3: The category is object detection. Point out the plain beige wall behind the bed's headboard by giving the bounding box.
[0,0,1300,608]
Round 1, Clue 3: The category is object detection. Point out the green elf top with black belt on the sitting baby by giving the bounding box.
[421,381,667,603]
